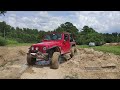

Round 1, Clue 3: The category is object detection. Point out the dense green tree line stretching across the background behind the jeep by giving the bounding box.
[0,21,120,45]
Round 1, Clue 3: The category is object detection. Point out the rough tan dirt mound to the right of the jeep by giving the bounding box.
[61,49,120,78]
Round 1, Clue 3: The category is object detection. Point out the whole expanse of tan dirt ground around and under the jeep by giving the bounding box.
[0,46,120,79]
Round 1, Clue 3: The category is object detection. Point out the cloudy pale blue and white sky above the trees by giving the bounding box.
[0,11,120,33]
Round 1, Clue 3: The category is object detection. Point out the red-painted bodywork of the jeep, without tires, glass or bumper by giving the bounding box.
[32,33,76,54]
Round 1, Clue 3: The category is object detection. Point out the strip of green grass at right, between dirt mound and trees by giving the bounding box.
[77,45,120,55]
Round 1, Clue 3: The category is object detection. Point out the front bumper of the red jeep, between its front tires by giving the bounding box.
[27,52,48,60]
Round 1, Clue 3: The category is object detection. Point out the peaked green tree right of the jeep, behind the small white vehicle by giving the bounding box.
[78,26,104,45]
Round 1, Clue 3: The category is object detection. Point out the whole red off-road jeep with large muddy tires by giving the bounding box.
[27,32,77,69]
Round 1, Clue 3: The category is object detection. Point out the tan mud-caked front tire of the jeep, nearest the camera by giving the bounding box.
[50,52,60,69]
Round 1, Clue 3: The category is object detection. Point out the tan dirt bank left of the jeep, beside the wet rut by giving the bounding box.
[0,46,28,79]
